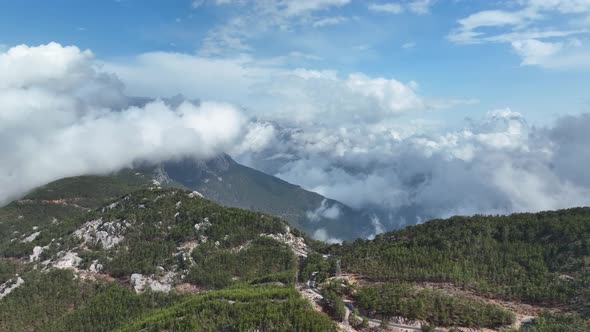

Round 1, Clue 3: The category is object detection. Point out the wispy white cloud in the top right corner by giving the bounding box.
[448,0,590,69]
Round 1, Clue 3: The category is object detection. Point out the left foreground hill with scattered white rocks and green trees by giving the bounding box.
[0,187,334,331]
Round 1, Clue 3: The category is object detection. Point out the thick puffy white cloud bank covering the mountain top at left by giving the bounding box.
[0,43,245,203]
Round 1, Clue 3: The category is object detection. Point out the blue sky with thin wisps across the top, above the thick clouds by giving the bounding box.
[0,0,590,124]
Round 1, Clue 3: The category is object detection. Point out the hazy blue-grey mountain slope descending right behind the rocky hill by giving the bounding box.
[155,155,374,239]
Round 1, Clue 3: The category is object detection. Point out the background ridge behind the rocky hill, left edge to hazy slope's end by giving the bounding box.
[0,155,374,246]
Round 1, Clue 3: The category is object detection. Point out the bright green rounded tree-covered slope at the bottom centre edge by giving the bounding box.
[121,285,336,332]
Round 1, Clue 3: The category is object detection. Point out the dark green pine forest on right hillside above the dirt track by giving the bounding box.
[328,208,590,319]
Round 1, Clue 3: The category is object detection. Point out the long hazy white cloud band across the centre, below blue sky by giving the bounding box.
[103,52,475,125]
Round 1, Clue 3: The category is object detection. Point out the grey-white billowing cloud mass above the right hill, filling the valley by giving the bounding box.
[238,109,590,229]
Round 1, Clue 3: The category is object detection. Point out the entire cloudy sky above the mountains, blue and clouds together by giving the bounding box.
[0,0,590,239]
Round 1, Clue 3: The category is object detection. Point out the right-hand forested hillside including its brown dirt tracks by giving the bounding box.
[316,208,590,331]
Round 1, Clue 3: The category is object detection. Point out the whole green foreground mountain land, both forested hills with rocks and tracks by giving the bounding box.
[0,180,590,332]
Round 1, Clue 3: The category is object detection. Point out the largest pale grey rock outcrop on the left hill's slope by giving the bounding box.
[74,218,128,249]
